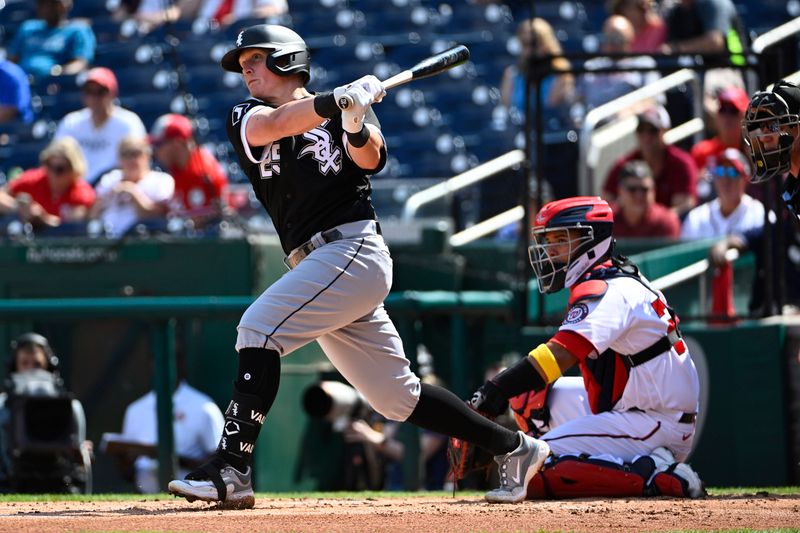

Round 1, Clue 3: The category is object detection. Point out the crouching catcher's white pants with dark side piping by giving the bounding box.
[541,377,695,462]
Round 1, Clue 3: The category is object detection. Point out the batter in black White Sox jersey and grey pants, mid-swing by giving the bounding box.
[169,25,549,508]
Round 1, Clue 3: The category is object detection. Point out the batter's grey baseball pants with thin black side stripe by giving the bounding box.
[236,220,420,421]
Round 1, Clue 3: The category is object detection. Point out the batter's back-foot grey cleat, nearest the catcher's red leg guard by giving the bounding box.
[486,431,550,503]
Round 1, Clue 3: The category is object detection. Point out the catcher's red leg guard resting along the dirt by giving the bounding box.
[527,456,655,500]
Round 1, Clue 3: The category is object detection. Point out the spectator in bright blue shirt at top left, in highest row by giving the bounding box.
[7,0,96,78]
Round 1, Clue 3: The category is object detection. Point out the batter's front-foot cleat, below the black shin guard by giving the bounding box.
[168,457,256,509]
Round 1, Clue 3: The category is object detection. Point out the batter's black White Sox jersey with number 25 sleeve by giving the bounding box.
[227,98,386,254]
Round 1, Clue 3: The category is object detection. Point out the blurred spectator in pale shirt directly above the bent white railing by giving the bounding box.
[578,15,659,109]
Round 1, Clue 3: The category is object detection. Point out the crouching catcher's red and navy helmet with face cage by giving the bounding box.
[528,196,614,293]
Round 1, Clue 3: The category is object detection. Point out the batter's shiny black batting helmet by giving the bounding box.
[220,24,311,84]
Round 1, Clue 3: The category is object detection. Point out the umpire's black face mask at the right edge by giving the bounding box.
[742,82,800,183]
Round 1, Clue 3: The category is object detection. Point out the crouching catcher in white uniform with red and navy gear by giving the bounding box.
[453,197,705,498]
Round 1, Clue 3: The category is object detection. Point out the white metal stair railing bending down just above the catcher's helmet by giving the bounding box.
[578,69,702,195]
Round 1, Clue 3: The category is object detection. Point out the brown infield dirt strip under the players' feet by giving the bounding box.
[0,494,800,533]
